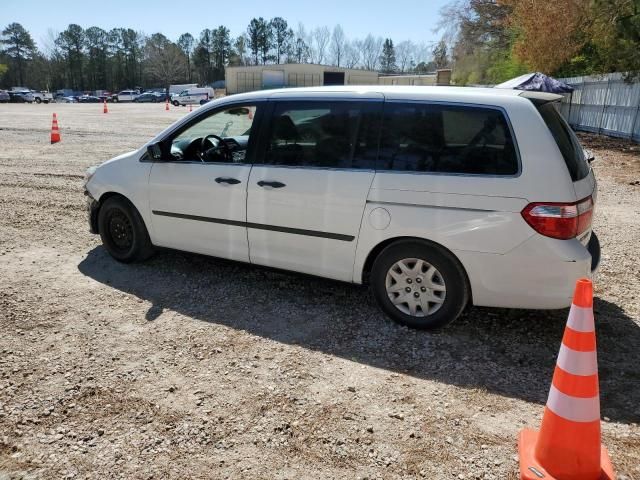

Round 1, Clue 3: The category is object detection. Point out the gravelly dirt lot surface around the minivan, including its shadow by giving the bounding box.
[0,104,640,480]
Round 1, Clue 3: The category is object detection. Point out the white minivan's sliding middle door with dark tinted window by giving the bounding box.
[247,97,382,281]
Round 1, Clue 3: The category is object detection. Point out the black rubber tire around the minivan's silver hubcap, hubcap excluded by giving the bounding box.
[370,240,469,330]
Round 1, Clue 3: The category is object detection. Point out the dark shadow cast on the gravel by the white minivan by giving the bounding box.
[78,247,640,423]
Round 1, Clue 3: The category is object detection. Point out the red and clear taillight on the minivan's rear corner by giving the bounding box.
[522,197,593,240]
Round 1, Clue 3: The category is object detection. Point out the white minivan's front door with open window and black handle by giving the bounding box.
[149,104,259,262]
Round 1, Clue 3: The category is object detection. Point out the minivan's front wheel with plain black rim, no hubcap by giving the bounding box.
[98,196,153,263]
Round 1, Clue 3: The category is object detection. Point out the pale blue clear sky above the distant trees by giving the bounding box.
[0,0,450,47]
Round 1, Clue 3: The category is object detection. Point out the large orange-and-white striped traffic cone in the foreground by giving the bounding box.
[518,278,615,480]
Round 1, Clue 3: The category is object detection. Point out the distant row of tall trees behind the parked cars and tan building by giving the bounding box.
[0,17,449,91]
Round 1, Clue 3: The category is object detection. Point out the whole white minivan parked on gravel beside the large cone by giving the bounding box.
[85,86,600,328]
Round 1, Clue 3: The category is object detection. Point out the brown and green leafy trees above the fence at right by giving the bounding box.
[440,0,640,85]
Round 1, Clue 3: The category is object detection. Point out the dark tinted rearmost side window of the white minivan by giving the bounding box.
[378,102,519,175]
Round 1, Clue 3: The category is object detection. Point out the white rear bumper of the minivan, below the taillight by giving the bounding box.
[454,234,600,309]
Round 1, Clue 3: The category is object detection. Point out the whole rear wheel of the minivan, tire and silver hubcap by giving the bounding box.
[370,240,469,330]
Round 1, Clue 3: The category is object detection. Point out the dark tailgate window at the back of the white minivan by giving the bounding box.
[536,102,589,182]
